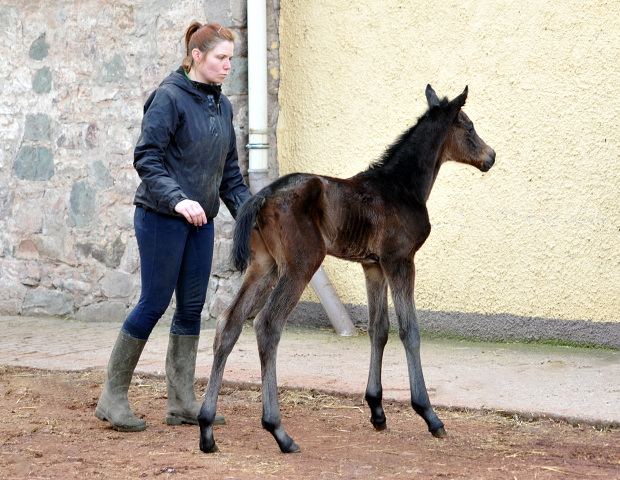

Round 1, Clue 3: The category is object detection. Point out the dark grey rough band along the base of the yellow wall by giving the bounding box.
[289,302,620,349]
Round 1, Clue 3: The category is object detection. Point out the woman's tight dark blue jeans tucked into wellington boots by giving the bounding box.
[122,207,214,340]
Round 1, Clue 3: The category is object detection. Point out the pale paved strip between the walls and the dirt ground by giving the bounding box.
[0,317,620,425]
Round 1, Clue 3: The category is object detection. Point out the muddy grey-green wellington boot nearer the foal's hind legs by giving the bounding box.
[166,333,226,425]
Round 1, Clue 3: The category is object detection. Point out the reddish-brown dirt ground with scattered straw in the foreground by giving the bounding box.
[0,367,620,480]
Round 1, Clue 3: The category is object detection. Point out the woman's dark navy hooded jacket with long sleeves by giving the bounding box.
[133,68,250,218]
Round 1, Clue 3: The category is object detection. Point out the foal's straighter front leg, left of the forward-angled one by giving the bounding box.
[364,265,390,430]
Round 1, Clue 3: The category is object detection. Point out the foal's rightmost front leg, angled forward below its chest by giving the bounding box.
[384,259,446,437]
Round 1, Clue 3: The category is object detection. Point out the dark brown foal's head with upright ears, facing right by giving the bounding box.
[426,85,495,172]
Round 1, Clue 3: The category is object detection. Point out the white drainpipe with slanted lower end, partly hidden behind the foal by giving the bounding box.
[247,0,357,336]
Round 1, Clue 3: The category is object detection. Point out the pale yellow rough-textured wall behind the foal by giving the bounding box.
[277,0,620,322]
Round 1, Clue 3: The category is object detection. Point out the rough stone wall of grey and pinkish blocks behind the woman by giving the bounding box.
[0,0,279,321]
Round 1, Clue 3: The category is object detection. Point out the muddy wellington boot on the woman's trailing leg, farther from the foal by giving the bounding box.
[95,332,146,432]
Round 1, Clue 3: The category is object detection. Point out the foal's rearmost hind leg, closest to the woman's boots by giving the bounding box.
[198,232,277,453]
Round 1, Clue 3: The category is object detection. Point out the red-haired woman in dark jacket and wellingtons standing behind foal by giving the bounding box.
[95,22,249,432]
